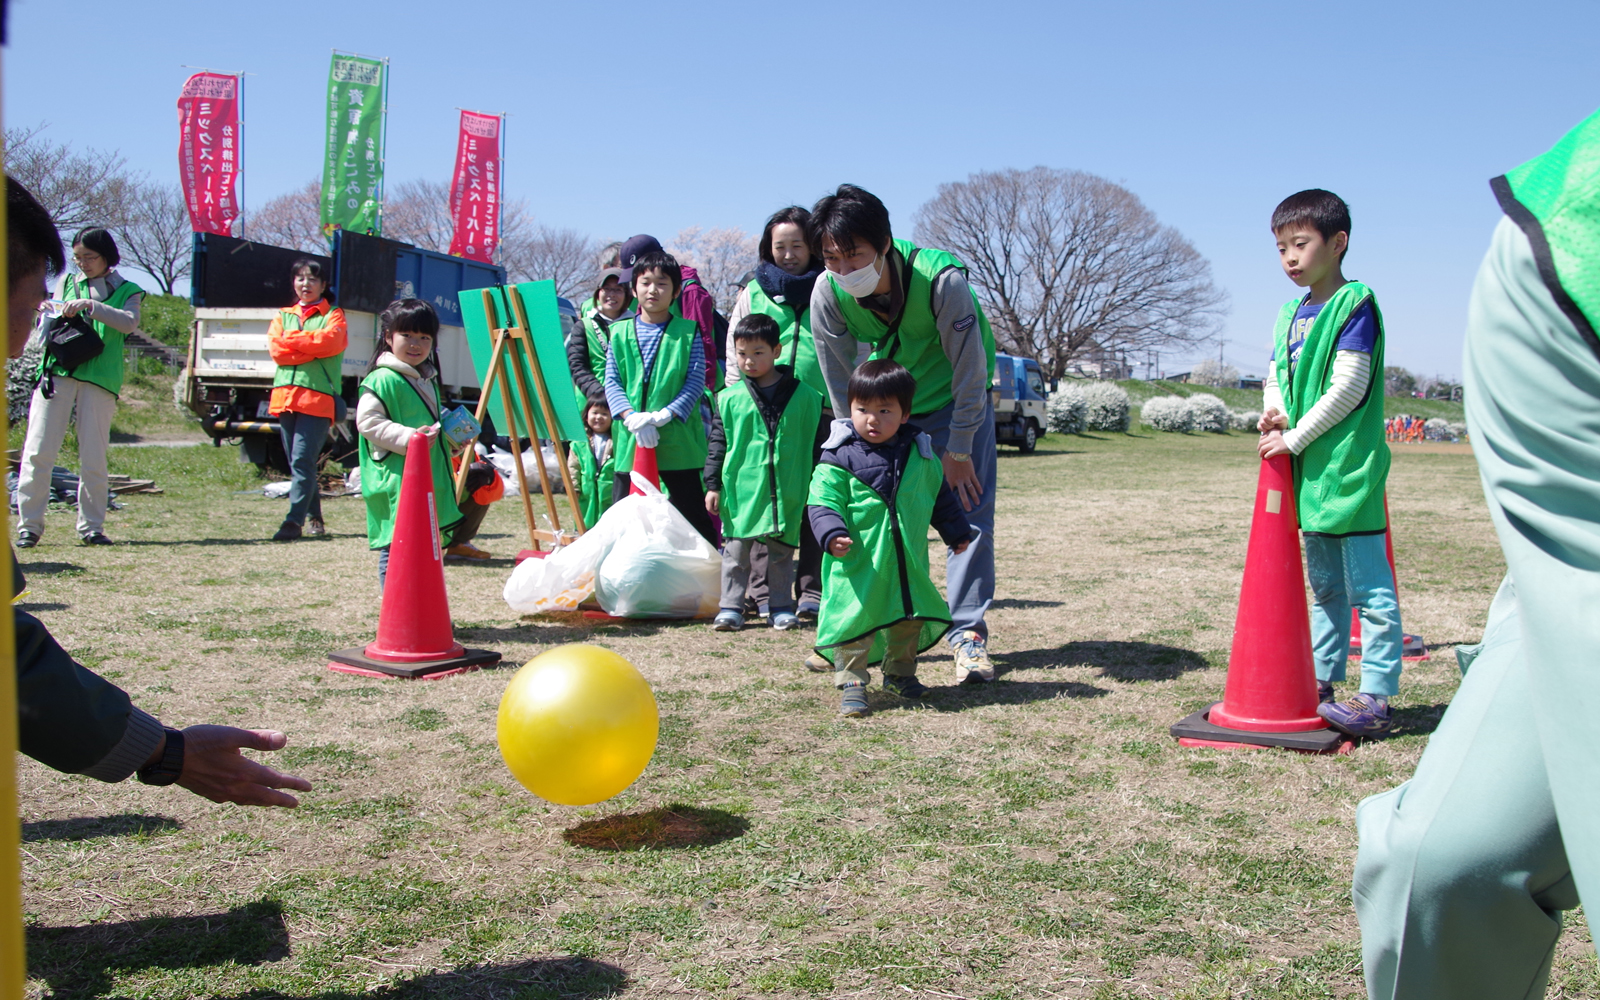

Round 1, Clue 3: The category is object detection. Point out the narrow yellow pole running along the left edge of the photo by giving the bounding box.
[0,37,27,1000]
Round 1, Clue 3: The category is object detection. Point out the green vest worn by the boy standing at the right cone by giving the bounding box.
[1272,282,1389,534]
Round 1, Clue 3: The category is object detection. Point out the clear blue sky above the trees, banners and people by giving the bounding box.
[5,0,1600,376]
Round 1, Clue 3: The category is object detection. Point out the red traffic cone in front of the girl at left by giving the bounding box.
[328,430,501,677]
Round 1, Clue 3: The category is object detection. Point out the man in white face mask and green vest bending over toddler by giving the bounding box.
[808,184,995,683]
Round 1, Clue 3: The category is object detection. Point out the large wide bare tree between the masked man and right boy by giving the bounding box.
[915,166,1227,378]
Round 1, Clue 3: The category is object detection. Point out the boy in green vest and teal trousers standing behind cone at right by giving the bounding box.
[1259,189,1402,736]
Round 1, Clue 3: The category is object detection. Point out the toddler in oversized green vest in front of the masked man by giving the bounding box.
[812,360,974,717]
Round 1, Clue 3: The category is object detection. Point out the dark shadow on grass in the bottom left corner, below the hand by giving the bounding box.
[27,899,290,997]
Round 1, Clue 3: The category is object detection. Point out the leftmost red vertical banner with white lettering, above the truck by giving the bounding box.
[178,74,242,237]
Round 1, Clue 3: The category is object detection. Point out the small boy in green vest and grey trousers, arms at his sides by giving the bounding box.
[706,314,822,632]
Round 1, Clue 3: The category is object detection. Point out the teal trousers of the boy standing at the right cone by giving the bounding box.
[1306,534,1403,698]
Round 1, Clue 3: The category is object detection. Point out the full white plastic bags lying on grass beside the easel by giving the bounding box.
[504,475,722,618]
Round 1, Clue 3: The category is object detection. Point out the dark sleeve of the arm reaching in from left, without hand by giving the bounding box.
[11,610,162,781]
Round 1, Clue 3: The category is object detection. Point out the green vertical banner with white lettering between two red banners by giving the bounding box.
[322,53,387,240]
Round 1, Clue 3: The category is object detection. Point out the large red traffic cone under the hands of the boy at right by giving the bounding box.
[1171,454,1344,752]
